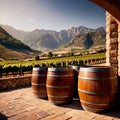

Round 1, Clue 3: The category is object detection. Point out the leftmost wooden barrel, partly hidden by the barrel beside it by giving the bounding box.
[31,67,48,98]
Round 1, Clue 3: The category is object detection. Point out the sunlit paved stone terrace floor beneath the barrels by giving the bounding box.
[0,87,120,120]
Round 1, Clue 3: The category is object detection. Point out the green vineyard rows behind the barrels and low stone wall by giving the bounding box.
[0,56,106,78]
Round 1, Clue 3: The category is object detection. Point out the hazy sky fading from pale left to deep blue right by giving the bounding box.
[0,0,105,31]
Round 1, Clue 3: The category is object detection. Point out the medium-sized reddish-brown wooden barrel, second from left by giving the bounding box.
[46,67,74,105]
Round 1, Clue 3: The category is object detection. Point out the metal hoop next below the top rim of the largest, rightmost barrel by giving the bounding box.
[78,76,117,80]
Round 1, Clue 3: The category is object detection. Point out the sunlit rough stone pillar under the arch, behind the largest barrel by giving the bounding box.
[106,12,118,74]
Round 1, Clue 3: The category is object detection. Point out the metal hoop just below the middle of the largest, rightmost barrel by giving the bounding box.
[78,88,117,95]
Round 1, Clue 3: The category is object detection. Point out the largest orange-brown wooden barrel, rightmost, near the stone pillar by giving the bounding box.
[78,66,118,112]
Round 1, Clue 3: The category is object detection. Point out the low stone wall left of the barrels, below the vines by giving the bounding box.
[0,76,31,91]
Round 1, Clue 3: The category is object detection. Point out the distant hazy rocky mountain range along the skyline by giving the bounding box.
[0,25,106,51]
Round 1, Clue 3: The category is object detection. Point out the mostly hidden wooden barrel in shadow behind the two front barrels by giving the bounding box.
[72,65,80,98]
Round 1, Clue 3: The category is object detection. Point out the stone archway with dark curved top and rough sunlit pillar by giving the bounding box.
[90,0,120,76]
